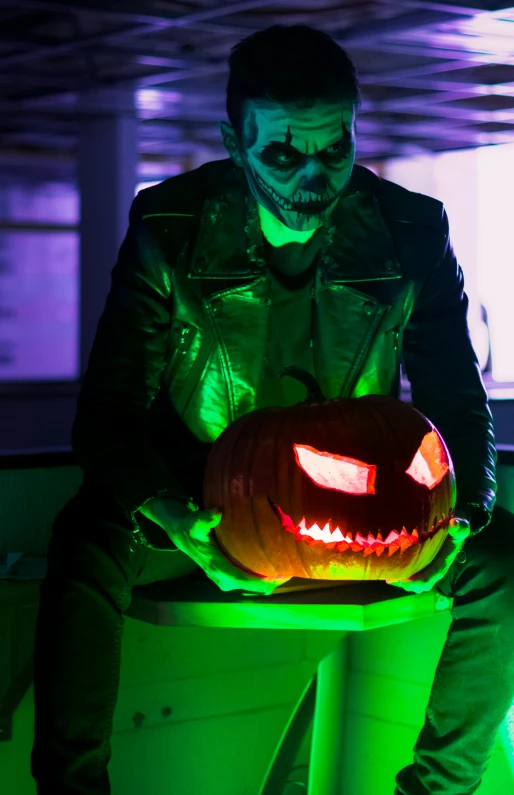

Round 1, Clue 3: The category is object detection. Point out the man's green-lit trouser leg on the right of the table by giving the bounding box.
[394,506,514,795]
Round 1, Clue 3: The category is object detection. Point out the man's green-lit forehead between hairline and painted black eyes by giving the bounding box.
[244,100,355,146]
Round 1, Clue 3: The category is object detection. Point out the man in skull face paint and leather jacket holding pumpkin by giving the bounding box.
[32,26,514,795]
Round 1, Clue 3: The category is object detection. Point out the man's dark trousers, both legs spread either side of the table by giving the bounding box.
[32,498,514,795]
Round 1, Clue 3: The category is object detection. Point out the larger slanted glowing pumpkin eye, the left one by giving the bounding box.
[293,444,377,494]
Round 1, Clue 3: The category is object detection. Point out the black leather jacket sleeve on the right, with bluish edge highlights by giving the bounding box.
[403,208,497,535]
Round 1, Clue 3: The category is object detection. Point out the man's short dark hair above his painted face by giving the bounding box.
[226,25,360,139]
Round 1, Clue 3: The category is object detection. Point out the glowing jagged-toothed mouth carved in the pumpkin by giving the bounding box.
[269,500,453,557]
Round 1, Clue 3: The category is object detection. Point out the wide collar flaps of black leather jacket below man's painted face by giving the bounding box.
[189,161,402,283]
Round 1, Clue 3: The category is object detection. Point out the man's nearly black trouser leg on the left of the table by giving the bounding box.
[31,490,198,795]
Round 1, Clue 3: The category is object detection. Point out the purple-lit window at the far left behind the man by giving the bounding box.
[0,180,79,381]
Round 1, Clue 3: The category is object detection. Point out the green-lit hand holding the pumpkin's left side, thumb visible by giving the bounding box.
[140,498,291,595]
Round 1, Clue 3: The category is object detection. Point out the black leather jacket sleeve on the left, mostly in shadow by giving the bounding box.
[72,197,190,532]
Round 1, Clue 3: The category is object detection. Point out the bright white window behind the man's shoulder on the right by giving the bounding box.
[380,144,514,397]
